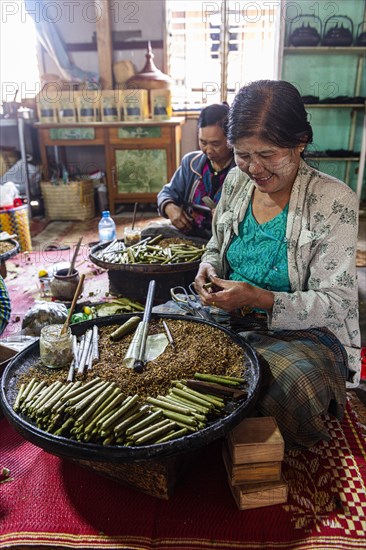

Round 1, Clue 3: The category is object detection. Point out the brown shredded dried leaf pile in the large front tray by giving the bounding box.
[18,320,245,399]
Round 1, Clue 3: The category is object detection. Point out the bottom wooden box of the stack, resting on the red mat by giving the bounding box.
[229,478,288,510]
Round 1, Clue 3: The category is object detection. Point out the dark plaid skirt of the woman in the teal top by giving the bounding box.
[239,328,348,448]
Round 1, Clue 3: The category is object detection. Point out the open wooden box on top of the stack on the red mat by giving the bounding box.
[226,416,285,464]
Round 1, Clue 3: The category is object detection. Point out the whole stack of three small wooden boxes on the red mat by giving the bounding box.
[223,416,288,510]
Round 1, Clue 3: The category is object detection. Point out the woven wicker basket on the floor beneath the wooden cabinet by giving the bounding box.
[41,180,95,221]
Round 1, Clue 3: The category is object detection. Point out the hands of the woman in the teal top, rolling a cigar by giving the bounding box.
[195,272,274,311]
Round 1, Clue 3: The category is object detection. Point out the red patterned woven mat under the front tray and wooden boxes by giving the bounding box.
[0,405,366,550]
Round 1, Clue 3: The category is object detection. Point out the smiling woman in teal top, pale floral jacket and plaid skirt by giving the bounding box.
[195,80,360,452]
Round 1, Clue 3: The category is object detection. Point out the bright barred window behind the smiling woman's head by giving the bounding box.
[166,0,281,110]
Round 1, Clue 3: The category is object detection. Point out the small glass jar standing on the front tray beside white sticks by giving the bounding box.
[39,325,73,369]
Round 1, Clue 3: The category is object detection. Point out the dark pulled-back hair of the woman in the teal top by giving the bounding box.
[227,80,313,148]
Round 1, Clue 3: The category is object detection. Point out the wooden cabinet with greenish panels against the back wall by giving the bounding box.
[37,118,185,214]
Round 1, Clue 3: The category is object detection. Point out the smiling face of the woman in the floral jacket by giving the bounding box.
[234,137,305,193]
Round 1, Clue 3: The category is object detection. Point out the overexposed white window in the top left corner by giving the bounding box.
[0,0,40,105]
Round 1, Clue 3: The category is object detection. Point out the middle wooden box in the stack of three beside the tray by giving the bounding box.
[222,444,282,485]
